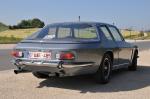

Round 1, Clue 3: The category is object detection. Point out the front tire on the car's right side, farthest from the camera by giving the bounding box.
[128,51,138,71]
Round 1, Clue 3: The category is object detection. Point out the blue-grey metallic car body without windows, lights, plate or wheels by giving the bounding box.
[12,22,137,76]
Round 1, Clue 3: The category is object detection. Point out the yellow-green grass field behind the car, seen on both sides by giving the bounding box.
[0,28,150,43]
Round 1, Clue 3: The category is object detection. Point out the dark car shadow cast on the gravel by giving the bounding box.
[38,66,150,93]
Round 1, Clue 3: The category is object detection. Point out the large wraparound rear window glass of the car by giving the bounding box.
[28,24,98,40]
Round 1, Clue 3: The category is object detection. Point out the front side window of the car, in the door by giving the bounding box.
[109,27,123,41]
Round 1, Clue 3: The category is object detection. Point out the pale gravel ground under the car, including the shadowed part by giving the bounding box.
[0,50,150,99]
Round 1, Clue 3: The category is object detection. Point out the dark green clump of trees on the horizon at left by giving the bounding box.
[9,18,45,29]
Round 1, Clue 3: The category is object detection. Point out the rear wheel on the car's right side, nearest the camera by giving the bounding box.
[95,54,112,84]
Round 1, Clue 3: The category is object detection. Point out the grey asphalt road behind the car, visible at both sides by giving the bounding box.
[0,41,150,71]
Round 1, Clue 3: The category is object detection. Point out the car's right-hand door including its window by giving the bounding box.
[108,26,132,65]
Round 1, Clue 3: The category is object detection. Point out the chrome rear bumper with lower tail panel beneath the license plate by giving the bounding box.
[12,60,94,76]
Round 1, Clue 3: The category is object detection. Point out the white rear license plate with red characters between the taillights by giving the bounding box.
[29,52,51,60]
